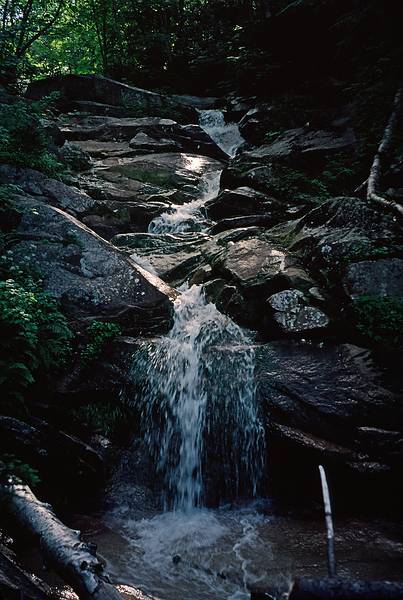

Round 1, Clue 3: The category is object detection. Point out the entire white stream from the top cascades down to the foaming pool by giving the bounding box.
[103,111,269,600]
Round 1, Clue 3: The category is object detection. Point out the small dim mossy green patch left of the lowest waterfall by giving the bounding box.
[72,402,134,437]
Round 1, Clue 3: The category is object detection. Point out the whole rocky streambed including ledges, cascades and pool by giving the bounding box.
[0,78,403,600]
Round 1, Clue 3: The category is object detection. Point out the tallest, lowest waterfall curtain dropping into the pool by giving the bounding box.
[135,286,264,511]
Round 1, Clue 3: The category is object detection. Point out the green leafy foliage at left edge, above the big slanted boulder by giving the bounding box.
[0,98,62,177]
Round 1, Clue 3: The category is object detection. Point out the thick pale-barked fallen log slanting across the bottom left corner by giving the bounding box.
[0,485,121,600]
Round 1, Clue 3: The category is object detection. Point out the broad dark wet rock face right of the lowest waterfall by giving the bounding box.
[256,340,403,495]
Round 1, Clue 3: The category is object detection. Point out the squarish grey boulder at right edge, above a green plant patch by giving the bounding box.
[343,258,403,300]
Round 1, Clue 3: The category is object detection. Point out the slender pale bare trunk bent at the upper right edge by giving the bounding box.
[367,85,403,218]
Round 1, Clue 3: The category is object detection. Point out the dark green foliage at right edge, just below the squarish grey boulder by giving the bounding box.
[353,295,403,350]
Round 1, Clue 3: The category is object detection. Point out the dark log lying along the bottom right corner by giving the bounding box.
[288,577,403,600]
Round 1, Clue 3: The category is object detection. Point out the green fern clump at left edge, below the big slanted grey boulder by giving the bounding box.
[0,266,73,405]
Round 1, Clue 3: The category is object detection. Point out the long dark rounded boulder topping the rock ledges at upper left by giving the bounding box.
[26,75,196,122]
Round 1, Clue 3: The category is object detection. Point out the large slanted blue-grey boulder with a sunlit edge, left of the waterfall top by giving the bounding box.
[12,196,175,333]
